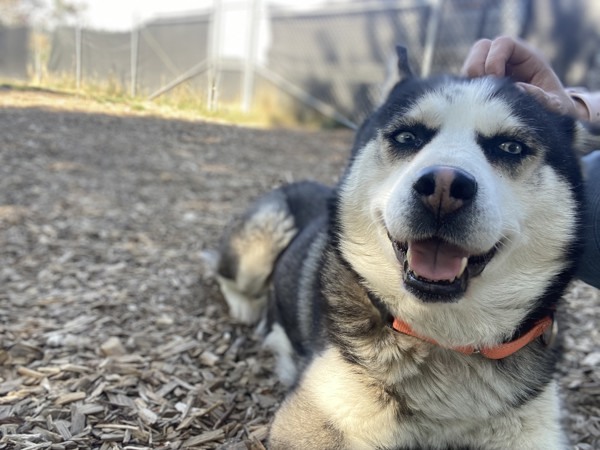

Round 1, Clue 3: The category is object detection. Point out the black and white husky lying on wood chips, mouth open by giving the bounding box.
[219,49,596,450]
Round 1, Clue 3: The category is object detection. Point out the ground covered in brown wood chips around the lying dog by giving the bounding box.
[0,88,600,450]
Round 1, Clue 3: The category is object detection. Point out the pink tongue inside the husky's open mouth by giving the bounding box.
[407,239,469,281]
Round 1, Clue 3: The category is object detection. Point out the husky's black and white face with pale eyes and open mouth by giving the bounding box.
[337,77,581,346]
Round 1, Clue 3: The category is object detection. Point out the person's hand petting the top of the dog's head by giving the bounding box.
[461,36,589,120]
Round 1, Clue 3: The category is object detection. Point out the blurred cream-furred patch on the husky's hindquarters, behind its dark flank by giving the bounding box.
[216,189,297,324]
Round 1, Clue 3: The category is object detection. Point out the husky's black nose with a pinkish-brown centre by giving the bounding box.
[413,166,477,217]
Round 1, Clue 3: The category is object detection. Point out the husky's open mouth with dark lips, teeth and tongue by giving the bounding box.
[388,234,499,302]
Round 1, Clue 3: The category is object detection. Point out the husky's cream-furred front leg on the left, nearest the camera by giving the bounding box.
[269,348,404,450]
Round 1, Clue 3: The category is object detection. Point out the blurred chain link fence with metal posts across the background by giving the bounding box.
[0,0,600,127]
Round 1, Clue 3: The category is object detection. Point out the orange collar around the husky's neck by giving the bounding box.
[392,316,556,359]
